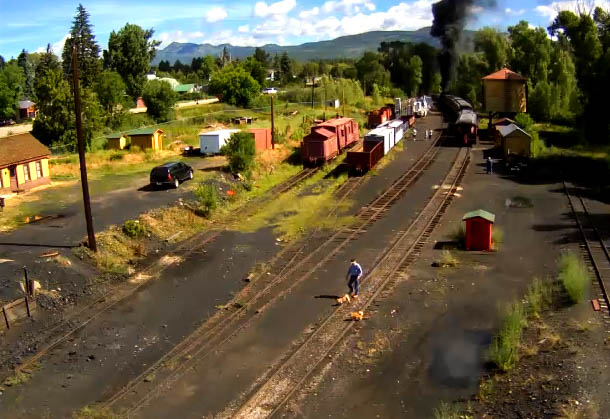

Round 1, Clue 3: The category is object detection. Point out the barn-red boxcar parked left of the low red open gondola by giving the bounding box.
[301,118,359,165]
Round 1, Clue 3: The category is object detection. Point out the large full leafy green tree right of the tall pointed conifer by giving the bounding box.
[104,23,160,100]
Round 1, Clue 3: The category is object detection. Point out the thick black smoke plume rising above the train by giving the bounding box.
[430,0,495,91]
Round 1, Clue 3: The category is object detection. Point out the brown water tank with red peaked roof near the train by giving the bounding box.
[482,68,527,114]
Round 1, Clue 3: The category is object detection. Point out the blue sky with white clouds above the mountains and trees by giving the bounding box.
[0,0,610,59]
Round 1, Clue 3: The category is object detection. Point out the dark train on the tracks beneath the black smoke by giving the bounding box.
[439,94,479,145]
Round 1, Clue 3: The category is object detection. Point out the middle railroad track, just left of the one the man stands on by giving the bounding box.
[103,131,442,416]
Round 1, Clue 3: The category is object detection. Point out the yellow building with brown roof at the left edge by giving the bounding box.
[0,133,51,193]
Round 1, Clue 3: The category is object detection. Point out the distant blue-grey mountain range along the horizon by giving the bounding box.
[152,28,473,65]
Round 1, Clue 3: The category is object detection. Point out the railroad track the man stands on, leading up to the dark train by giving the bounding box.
[234,148,470,419]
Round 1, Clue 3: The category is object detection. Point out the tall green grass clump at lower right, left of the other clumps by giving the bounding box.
[488,301,527,371]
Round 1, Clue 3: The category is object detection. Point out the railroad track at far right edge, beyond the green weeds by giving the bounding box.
[563,181,610,320]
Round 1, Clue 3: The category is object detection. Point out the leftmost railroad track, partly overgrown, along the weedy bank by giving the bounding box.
[7,163,320,378]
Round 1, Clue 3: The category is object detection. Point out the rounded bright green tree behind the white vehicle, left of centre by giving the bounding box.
[209,66,261,106]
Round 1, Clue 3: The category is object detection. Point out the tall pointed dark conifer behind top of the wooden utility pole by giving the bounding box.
[62,4,102,88]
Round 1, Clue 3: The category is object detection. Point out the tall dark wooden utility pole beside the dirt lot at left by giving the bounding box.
[72,43,97,252]
